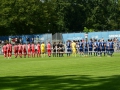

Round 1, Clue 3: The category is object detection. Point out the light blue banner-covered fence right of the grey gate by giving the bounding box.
[62,31,120,42]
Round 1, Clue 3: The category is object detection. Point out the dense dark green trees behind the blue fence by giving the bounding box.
[0,0,120,35]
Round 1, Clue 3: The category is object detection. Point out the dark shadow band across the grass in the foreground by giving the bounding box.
[0,75,120,90]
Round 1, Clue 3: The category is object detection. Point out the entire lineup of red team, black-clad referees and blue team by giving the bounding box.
[2,39,114,58]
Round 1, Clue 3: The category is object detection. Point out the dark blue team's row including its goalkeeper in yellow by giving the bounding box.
[67,39,114,56]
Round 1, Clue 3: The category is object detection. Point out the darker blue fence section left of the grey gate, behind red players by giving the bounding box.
[0,34,52,44]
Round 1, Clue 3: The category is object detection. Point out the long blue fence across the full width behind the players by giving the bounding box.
[0,31,120,43]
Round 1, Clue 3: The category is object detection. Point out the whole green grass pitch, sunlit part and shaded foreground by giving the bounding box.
[0,53,120,90]
